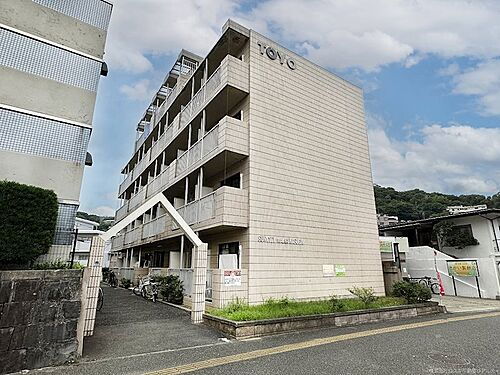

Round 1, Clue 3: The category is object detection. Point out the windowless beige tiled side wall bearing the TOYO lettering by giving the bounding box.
[248,31,384,303]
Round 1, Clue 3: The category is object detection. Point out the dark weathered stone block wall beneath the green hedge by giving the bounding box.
[0,270,82,374]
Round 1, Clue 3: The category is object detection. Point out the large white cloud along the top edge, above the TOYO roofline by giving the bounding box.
[246,0,500,71]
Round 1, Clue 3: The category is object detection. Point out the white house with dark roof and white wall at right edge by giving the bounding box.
[380,209,500,298]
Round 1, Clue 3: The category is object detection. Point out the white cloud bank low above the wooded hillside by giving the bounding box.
[368,119,500,194]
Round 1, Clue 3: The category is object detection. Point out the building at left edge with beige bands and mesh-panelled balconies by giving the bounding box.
[0,0,112,259]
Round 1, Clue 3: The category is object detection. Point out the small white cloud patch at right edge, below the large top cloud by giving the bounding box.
[453,60,500,116]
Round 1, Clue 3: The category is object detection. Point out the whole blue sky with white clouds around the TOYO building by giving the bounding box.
[81,0,500,215]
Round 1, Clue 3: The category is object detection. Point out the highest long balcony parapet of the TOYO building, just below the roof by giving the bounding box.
[119,55,249,198]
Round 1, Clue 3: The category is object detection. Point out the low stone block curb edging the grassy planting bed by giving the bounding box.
[203,302,446,339]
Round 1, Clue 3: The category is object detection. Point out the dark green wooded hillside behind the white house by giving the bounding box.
[374,185,500,220]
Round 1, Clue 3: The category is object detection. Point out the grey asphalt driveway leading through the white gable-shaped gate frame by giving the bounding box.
[83,286,222,361]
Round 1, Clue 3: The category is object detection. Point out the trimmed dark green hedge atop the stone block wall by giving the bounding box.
[0,181,58,269]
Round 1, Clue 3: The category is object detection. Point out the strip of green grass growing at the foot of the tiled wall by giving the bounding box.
[210,297,406,321]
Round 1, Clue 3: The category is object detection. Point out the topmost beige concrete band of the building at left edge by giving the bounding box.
[0,0,106,58]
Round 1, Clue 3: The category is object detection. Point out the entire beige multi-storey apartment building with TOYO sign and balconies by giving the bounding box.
[111,20,384,306]
